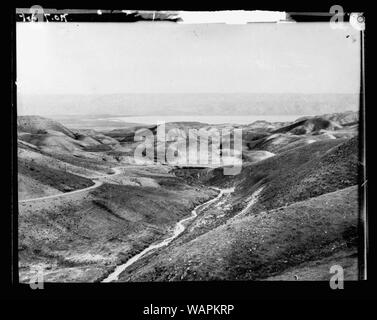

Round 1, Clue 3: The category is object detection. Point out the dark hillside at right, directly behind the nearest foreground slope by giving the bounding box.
[201,137,358,211]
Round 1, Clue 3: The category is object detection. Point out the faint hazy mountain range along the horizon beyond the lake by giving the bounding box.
[17,93,359,116]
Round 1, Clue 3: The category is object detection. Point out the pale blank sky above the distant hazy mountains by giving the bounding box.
[17,22,360,94]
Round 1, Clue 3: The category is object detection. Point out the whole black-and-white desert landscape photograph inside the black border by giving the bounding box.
[8,6,368,298]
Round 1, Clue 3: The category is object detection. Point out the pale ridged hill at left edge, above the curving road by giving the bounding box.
[17,116,118,200]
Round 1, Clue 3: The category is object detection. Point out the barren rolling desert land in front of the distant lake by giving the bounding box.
[17,111,359,282]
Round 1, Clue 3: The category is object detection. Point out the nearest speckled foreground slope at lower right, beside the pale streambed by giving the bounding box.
[121,187,358,281]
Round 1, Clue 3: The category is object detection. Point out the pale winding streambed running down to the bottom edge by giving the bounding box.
[102,187,234,282]
